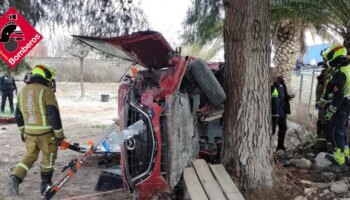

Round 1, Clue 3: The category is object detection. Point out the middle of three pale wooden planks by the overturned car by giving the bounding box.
[193,159,226,200]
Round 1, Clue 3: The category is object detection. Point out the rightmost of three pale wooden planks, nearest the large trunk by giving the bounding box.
[210,164,244,200]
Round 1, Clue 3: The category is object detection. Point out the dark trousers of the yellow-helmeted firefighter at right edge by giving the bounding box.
[331,103,350,152]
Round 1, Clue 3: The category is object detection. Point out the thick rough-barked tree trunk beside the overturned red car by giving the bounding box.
[222,0,273,188]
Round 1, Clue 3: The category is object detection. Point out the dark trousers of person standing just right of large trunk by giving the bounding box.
[272,115,287,150]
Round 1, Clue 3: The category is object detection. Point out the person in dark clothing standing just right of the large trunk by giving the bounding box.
[271,76,294,151]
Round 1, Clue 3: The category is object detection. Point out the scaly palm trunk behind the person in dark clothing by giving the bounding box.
[273,21,301,92]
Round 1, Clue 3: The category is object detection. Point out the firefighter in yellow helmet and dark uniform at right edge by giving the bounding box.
[322,44,350,169]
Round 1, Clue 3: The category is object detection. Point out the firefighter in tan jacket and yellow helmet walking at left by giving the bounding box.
[8,65,64,195]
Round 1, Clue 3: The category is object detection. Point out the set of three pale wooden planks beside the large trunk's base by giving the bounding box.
[183,159,244,200]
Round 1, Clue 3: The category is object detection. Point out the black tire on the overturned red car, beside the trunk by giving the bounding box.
[188,59,226,107]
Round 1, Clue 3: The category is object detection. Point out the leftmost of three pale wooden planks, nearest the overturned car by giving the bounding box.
[184,167,208,200]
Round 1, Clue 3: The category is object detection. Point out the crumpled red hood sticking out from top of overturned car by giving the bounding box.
[73,31,174,69]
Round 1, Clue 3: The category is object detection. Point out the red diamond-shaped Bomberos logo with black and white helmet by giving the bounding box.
[0,8,43,68]
